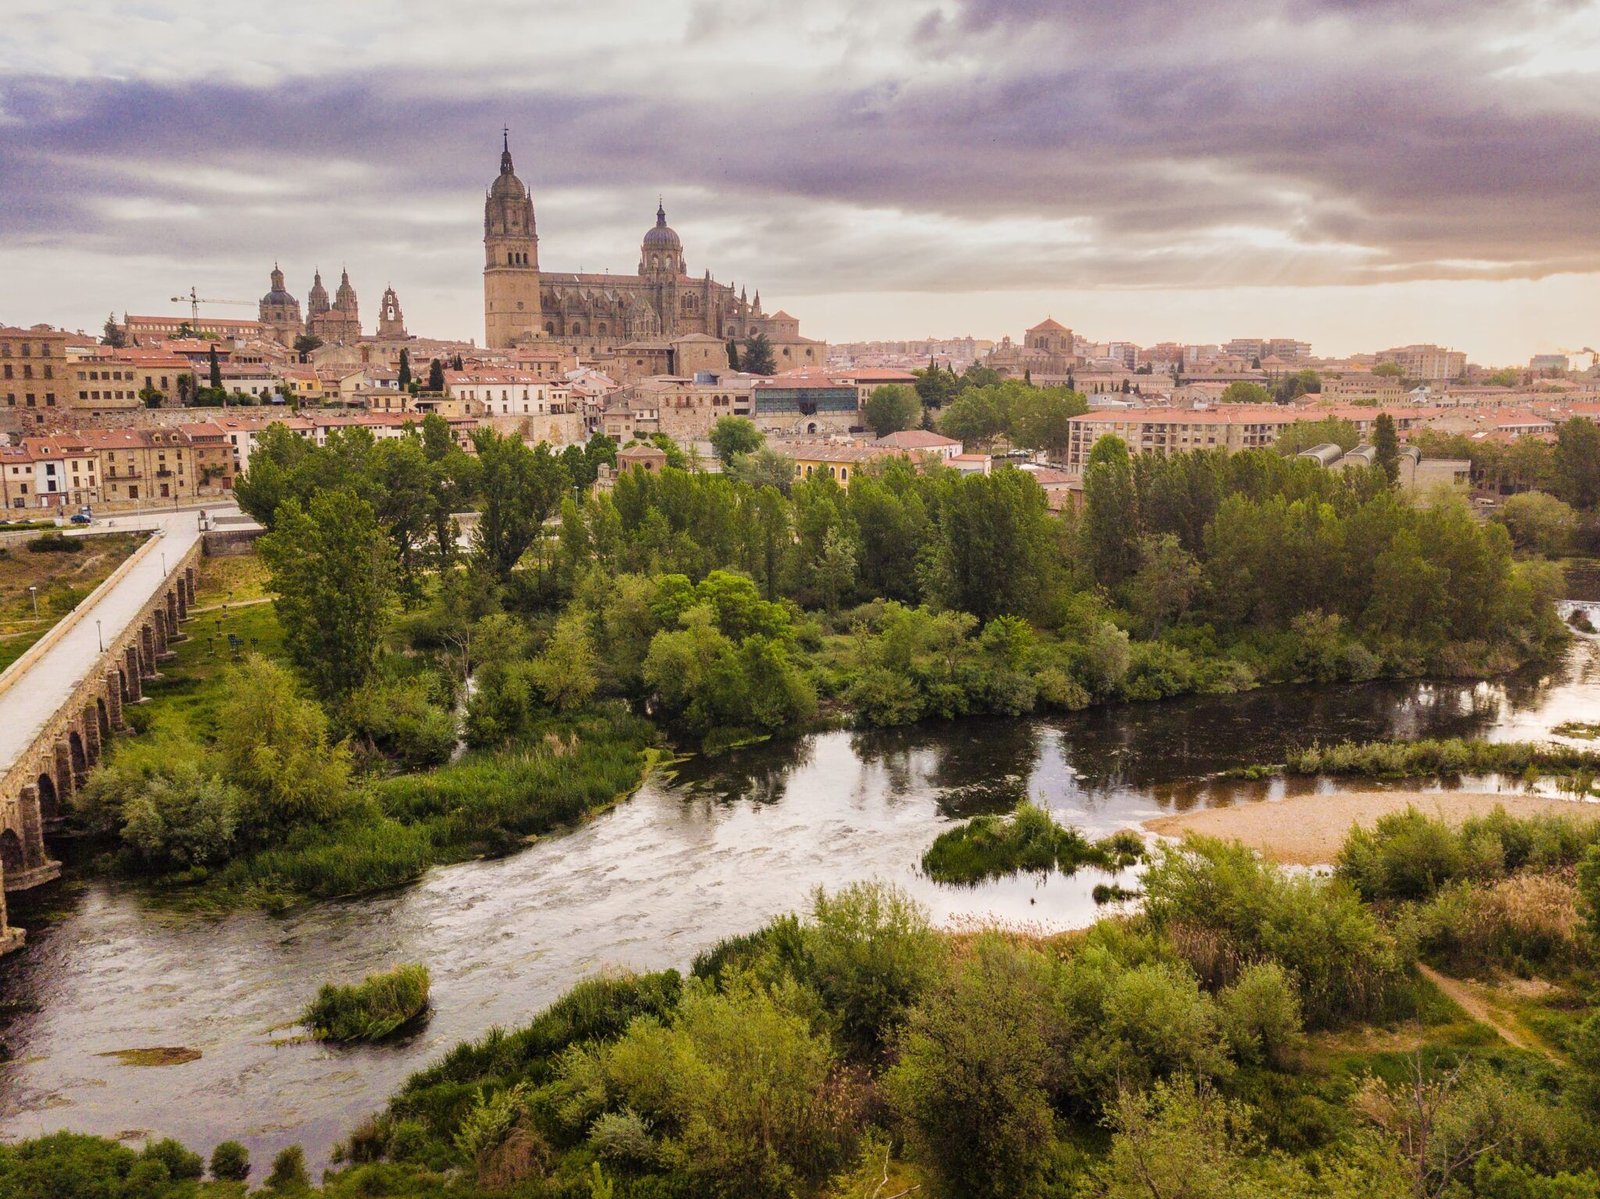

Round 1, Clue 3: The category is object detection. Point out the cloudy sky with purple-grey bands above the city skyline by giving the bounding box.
[0,0,1600,362]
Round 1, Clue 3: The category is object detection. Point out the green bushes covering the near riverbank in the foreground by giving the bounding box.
[15,812,1600,1199]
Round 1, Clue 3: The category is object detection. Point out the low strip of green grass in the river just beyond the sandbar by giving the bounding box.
[1285,738,1600,778]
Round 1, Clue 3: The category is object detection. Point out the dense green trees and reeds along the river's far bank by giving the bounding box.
[59,406,1566,904]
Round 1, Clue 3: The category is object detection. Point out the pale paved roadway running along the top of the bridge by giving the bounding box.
[0,509,237,773]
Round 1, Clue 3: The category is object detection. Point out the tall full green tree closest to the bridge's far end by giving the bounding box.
[261,488,394,698]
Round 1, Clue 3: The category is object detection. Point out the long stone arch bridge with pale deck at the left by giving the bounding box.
[0,515,202,952]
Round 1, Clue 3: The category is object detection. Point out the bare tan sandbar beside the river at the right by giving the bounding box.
[1144,791,1600,866]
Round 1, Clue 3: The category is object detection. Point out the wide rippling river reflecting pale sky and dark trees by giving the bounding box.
[0,639,1600,1162]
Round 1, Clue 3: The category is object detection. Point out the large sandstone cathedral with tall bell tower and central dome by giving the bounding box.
[483,134,827,370]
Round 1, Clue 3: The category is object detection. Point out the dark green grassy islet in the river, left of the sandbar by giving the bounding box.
[922,804,1142,885]
